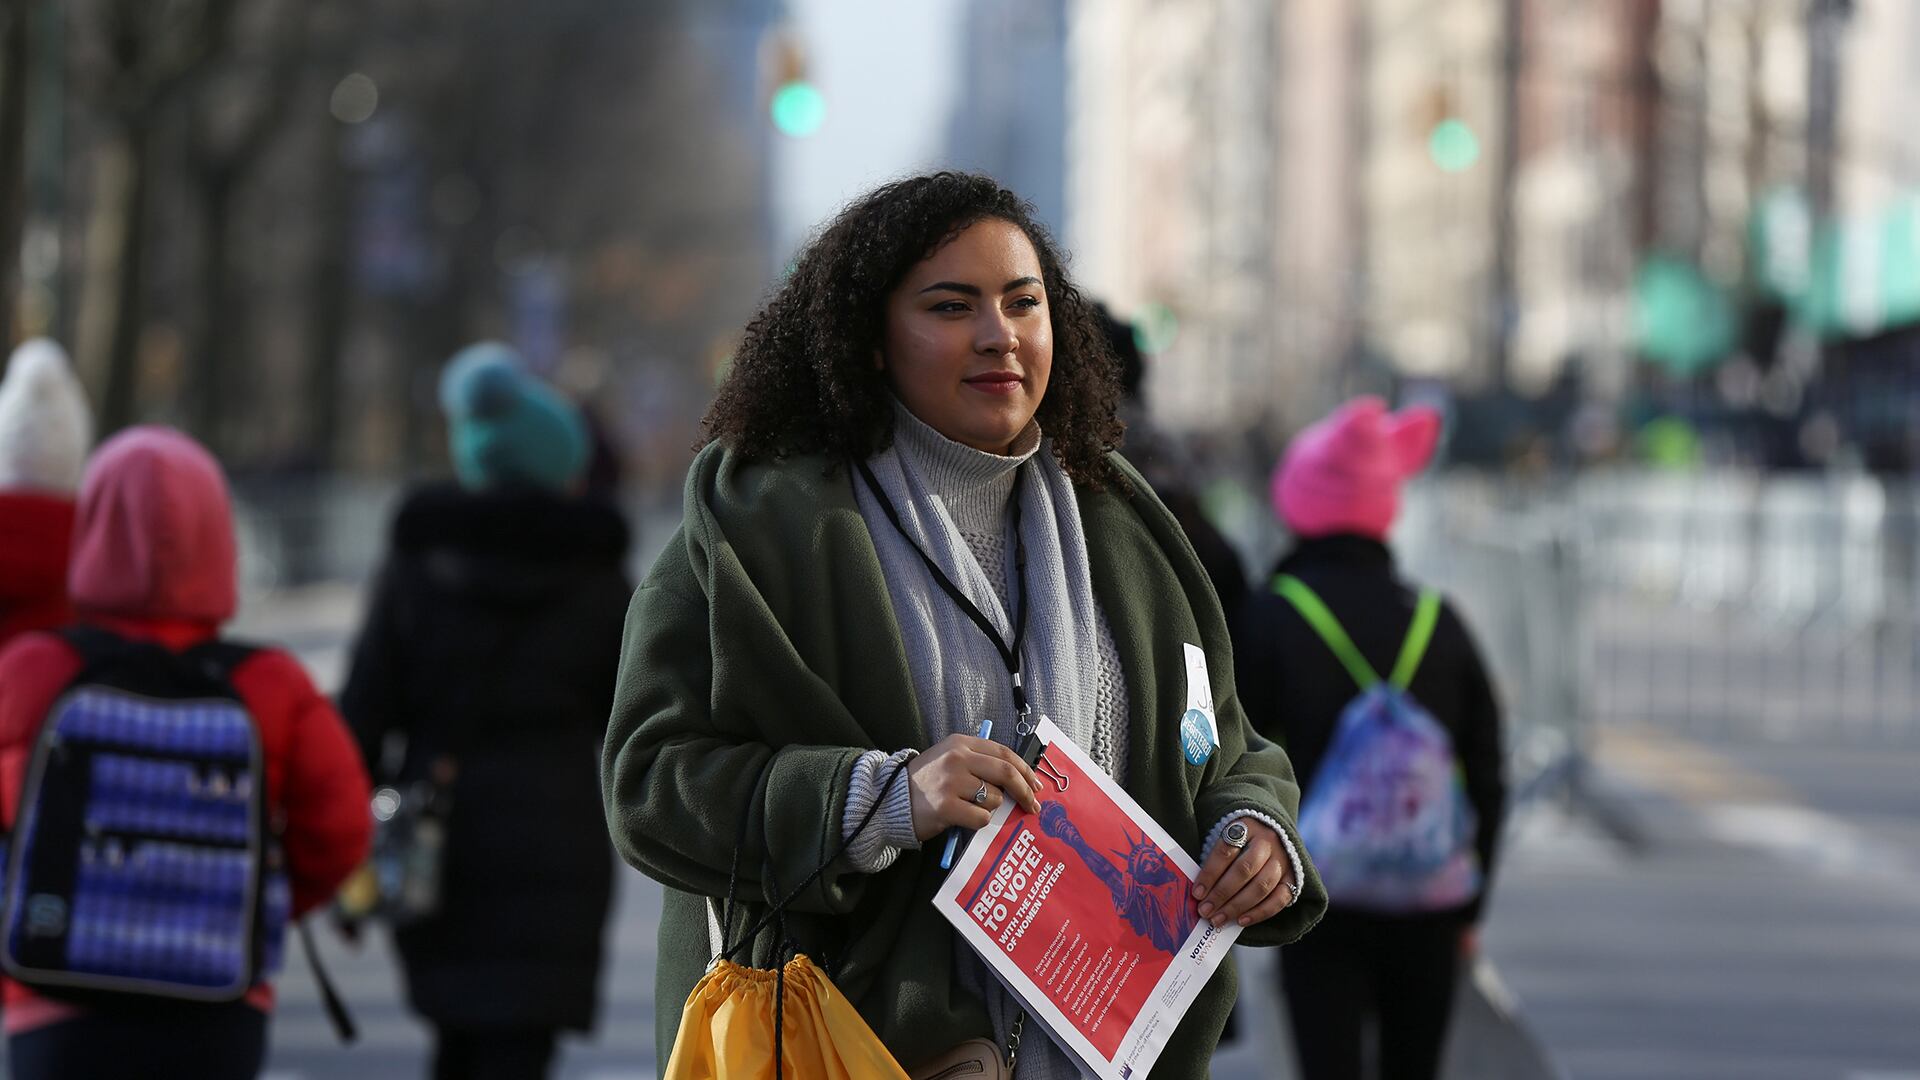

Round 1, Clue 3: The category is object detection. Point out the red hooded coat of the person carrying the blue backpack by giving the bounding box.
[0,429,372,1034]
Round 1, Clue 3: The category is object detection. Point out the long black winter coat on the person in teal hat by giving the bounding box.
[340,486,634,1030]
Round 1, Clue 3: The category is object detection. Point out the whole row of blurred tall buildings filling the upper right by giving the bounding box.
[1068,0,1920,468]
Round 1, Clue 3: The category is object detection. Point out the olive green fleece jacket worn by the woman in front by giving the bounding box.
[601,444,1327,1080]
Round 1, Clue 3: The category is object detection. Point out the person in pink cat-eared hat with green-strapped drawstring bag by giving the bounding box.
[1235,398,1505,1080]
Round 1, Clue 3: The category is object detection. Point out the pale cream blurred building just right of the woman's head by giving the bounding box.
[1068,0,1286,429]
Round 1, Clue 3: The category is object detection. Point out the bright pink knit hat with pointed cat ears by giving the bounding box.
[1273,396,1440,540]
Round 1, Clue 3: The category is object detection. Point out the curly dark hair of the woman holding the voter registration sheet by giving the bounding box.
[701,173,1123,488]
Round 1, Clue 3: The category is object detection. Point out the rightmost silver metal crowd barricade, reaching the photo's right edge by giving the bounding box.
[1578,473,1920,744]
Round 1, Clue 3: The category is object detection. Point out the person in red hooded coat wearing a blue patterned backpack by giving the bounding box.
[0,427,371,1080]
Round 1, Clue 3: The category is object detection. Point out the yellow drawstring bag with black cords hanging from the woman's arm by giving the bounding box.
[660,749,908,1080]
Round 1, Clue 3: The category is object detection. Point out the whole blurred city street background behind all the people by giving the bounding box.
[0,0,1920,1080]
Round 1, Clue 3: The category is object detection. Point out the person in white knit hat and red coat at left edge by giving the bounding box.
[0,338,94,646]
